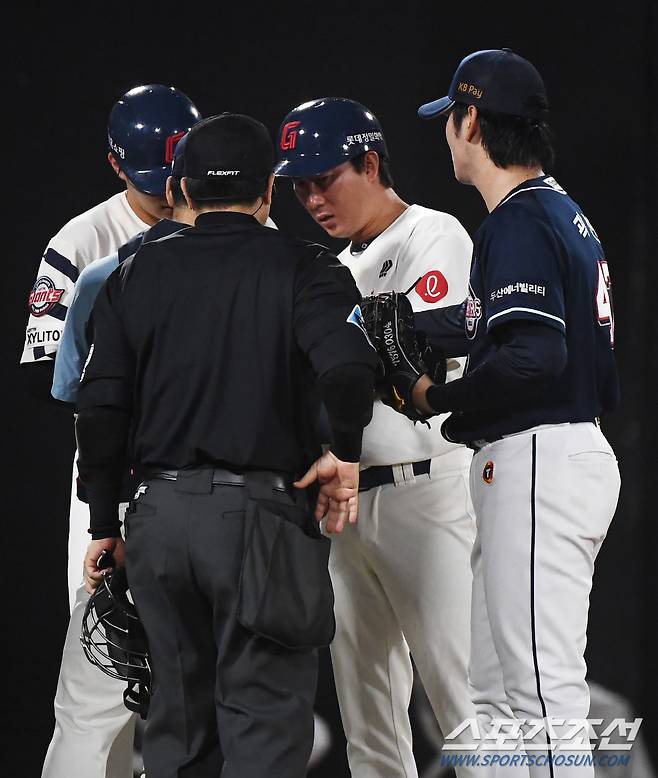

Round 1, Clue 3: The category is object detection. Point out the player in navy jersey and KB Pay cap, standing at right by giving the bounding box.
[412,49,620,778]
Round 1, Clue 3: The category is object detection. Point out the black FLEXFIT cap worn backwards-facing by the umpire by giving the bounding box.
[174,113,274,201]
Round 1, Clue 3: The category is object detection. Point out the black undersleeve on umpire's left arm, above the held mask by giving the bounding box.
[75,406,130,540]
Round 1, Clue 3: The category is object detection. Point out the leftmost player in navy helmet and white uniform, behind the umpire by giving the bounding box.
[21,84,201,778]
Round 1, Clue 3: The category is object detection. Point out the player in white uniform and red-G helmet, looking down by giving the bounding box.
[276,98,475,778]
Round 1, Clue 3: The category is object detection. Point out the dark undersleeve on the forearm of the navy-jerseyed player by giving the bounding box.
[426,321,567,413]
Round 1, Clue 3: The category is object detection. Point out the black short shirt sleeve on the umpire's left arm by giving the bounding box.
[77,265,135,411]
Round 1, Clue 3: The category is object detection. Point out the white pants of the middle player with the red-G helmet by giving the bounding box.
[330,449,476,778]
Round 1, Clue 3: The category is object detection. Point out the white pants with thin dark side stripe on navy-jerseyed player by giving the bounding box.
[469,423,620,778]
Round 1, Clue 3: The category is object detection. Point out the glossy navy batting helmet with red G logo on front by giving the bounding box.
[274,97,388,178]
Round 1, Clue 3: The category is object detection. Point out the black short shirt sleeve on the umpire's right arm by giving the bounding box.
[293,252,379,377]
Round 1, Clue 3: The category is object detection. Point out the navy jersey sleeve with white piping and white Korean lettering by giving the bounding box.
[481,206,566,332]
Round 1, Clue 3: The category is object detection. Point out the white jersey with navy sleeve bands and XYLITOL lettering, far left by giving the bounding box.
[21,192,149,363]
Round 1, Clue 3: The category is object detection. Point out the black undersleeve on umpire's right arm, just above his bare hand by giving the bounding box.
[318,363,375,462]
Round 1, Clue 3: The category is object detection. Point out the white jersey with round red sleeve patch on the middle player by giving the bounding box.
[339,205,473,468]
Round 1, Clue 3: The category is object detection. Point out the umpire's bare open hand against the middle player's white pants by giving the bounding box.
[294,451,359,533]
